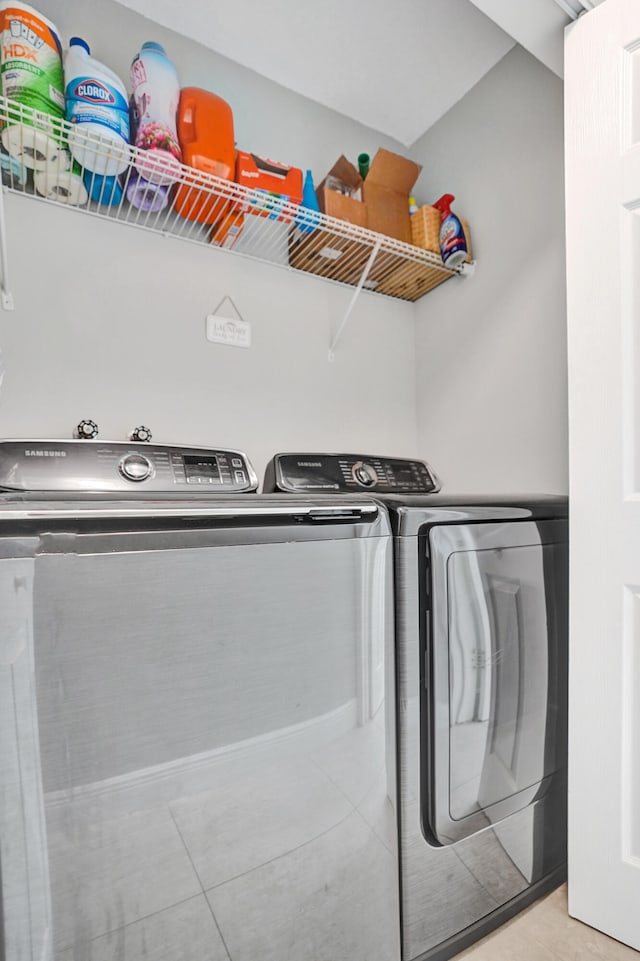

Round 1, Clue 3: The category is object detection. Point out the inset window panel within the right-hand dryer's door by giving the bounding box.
[448,545,553,819]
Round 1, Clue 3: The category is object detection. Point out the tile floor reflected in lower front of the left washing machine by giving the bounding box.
[47,720,398,961]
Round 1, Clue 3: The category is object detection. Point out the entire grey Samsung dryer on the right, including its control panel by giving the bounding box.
[264,453,568,961]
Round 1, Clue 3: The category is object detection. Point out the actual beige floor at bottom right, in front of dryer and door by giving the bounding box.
[454,885,640,961]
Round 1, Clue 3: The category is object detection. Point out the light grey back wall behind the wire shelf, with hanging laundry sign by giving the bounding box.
[0,0,416,476]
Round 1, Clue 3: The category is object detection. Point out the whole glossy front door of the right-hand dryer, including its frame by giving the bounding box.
[423,520,568,844]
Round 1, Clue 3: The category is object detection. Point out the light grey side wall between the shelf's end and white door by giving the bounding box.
[412,47,568,492]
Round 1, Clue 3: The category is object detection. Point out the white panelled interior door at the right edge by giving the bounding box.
[565,0,640,948]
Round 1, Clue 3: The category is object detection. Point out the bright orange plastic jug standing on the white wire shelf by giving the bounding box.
[173,87,236,224]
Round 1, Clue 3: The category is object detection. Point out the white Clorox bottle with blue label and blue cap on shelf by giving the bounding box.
[64,37,130,177]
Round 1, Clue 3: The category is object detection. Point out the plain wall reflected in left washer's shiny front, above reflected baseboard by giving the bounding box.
[35,541,360,791]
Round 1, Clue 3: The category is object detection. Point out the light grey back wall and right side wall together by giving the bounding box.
[0,0,567,491]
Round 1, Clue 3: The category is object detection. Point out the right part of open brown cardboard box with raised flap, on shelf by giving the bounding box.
[362,148,422,244]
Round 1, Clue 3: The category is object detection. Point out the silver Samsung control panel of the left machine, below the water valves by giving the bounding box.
[0,440,258,496]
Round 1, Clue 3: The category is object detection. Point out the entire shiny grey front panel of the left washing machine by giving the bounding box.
[0,517,400,961]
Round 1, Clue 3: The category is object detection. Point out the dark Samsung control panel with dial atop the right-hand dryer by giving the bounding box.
[263,454,439,494]
